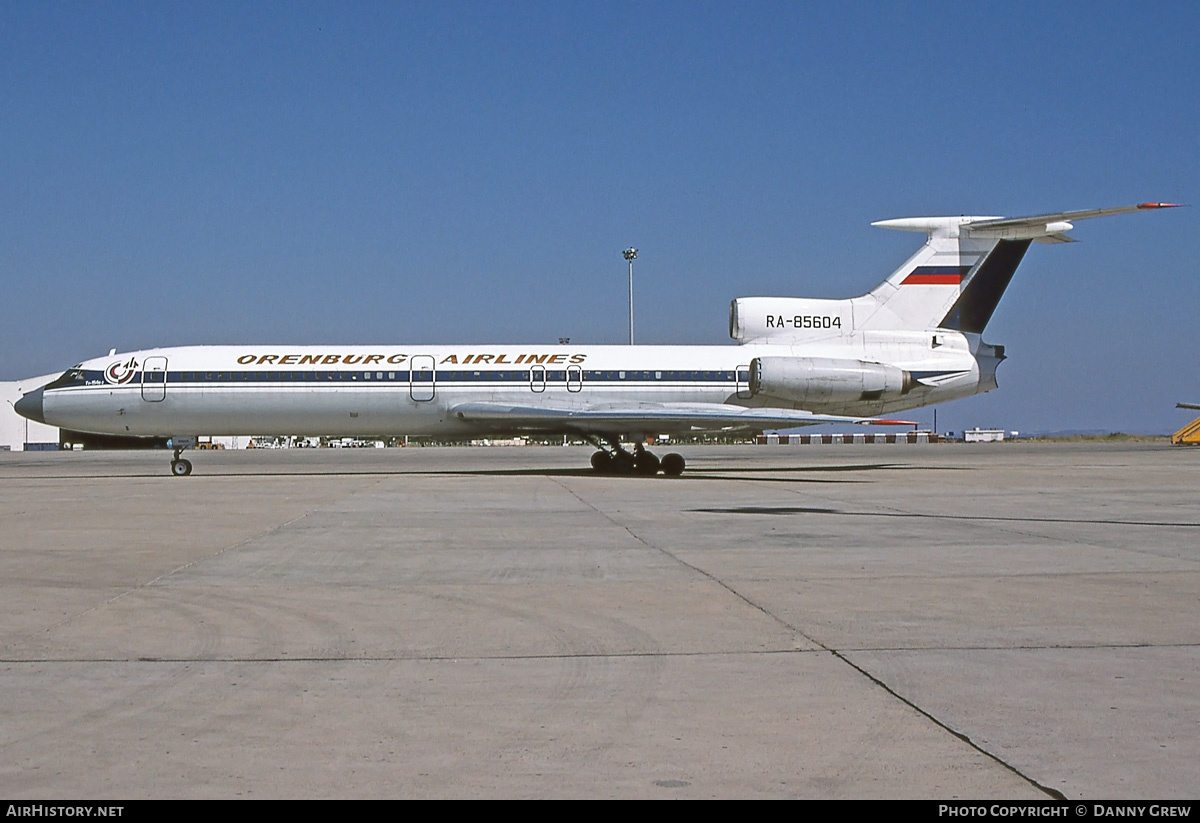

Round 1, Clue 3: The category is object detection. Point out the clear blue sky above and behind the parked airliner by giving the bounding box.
[0,0,1200,432]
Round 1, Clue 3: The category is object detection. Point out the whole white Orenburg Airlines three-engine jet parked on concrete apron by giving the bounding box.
[14,203,1177,476]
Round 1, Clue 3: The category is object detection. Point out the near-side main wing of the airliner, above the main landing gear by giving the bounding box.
[450,403,913,434]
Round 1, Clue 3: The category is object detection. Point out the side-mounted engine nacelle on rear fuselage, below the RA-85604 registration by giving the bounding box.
[750,358,918,408]
